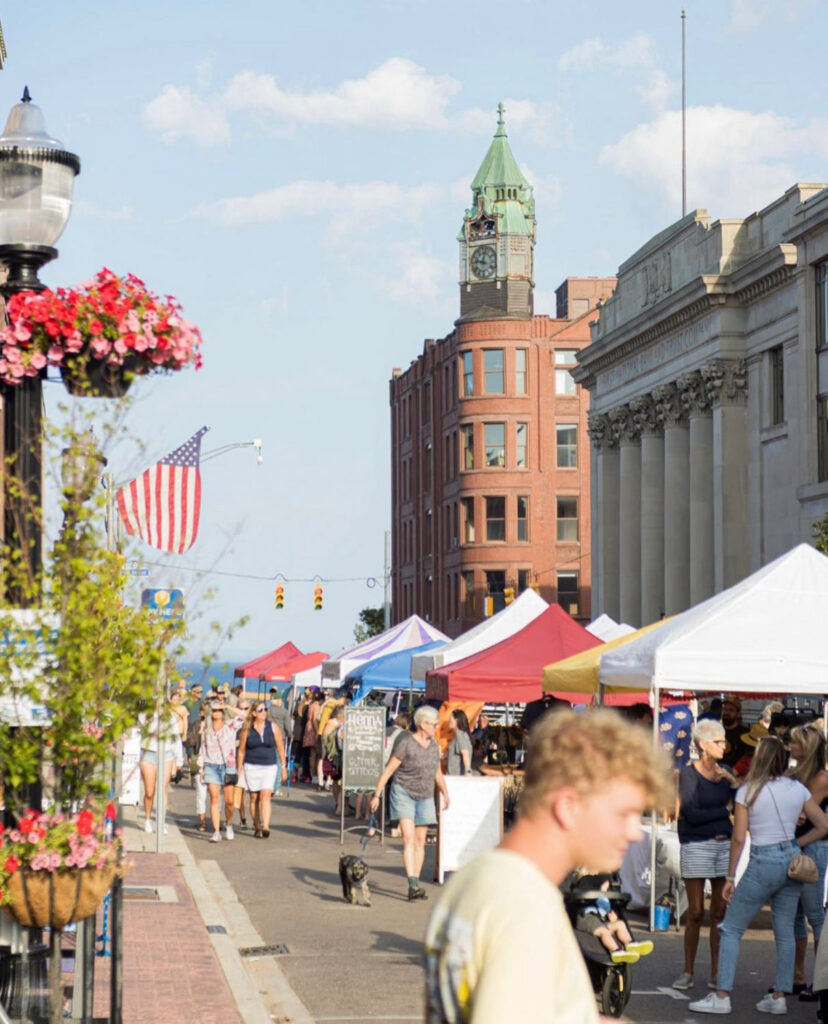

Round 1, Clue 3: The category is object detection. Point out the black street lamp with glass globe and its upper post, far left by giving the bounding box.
[0,87,81,606]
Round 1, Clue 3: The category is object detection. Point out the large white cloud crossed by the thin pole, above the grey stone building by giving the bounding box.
[600,106,828,216]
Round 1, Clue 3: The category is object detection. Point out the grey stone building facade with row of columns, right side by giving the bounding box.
[573,184,828,626]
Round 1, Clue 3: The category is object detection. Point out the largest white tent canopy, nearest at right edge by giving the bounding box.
[599,544,828,696]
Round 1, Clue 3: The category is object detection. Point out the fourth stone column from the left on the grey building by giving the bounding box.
[653,384,690,615]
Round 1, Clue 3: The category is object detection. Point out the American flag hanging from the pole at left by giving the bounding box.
[116,427,209,555]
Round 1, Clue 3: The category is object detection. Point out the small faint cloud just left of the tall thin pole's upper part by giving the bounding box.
[558,32,676,111]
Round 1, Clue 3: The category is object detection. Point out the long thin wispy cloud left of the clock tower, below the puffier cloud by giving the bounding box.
[193,179,442,239]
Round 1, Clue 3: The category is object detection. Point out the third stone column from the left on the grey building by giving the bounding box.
[629,394,664,626]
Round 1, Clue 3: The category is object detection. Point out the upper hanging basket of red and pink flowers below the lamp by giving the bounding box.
[0,268,202,397]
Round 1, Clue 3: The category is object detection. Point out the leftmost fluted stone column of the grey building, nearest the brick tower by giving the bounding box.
[589,414,619,620]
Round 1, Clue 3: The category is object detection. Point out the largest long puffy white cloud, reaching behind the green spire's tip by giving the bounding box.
[143,57,568,145]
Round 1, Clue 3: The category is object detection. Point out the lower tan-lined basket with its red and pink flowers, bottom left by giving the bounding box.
[0,804,121,929]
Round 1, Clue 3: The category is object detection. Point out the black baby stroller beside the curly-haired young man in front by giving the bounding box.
[563,874,635,1017]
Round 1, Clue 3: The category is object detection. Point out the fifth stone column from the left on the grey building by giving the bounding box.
[677,371,715,605]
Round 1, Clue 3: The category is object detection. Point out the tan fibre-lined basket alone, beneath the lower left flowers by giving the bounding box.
[6,864,116,928]
